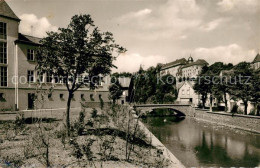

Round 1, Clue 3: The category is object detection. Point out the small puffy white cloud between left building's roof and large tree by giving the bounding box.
[19,14,58,37]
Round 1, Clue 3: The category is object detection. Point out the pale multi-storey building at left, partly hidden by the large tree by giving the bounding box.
[0,0,110,110]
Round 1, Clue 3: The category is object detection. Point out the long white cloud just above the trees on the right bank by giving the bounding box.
[192,43,256,64]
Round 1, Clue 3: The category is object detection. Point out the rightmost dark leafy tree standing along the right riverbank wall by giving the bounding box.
[230,62,254,115]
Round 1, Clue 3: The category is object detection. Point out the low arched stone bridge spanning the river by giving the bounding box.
[134,104,194,116]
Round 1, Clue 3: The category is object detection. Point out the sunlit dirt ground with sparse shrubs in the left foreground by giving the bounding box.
[0,108,169,168]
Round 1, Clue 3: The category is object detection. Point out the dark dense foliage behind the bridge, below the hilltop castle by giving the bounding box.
[129,65,177,103]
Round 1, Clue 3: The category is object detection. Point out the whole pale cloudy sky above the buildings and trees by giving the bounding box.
[6,0,260,72]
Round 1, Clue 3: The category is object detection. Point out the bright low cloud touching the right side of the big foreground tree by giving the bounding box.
[113,53,166,72]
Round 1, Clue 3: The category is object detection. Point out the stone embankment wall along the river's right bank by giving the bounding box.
[185,107,260,134]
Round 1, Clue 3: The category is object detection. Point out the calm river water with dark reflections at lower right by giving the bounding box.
[143,117,260,167]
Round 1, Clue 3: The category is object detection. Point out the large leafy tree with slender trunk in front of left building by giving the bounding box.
[36,15,126,135]
